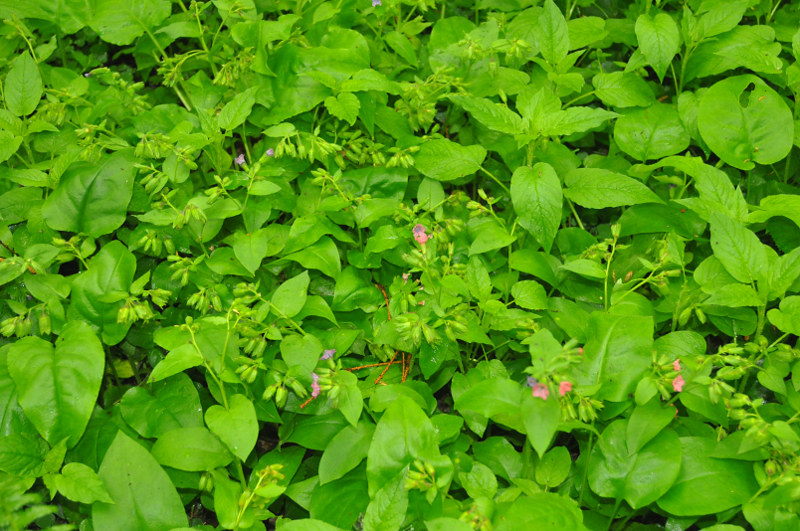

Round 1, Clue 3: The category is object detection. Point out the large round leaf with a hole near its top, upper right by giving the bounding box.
[697,75,794,170]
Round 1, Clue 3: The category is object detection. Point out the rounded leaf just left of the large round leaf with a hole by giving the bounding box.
[614,103,690,161]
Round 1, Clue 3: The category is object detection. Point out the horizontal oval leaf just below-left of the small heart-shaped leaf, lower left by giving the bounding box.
[151,427,233,472]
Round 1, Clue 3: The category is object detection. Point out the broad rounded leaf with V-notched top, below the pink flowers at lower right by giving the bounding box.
[588,419,681,509]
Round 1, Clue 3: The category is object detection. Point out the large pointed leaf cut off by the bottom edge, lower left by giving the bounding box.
[92,430,189,531]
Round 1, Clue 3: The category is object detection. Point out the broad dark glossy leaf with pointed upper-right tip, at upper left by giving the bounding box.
[42,149,136,238]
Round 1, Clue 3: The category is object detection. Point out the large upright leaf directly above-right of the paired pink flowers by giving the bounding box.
[576,312,654,402]
